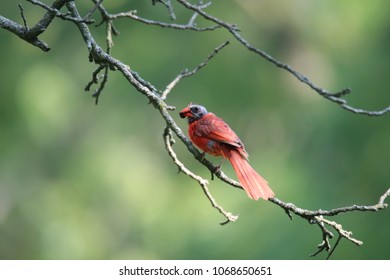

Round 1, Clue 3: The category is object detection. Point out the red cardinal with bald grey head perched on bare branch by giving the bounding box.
[180,104,274,200]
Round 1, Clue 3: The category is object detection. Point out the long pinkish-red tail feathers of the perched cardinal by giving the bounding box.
[224,149,274,200]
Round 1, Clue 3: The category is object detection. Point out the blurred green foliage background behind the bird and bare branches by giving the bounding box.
[0,0,390,259]
